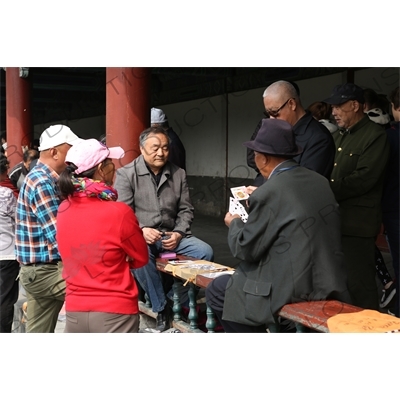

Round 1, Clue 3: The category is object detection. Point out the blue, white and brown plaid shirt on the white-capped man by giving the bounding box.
[15,161,61,264]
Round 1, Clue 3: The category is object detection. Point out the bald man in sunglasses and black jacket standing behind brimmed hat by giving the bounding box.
[249,81,335,186]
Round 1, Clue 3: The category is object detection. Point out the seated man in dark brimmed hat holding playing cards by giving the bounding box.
[206,119,350,332]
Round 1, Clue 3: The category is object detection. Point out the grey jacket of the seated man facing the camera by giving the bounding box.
[114,156,193,235]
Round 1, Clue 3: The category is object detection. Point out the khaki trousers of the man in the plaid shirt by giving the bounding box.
[19,262,65,333]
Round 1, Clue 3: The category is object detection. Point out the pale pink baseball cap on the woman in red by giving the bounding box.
[65,139,125,175]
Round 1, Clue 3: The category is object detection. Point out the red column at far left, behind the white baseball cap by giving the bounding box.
[6,67,33,168]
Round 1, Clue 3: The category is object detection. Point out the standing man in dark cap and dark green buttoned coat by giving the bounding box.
[324,83,389,310]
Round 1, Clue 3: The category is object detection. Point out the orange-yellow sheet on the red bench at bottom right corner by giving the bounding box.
[327,310,400,333]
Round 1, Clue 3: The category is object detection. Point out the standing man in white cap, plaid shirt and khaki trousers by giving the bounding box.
[15,125,82,333]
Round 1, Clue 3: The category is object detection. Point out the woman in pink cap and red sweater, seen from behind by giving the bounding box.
[57,139,148,333]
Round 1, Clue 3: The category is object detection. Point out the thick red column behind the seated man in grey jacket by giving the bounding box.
[106,68,151,168]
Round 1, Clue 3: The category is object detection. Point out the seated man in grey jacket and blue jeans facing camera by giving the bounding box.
[115,127,213,331]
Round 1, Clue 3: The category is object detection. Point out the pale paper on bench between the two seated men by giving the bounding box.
[164,260,235,285]
